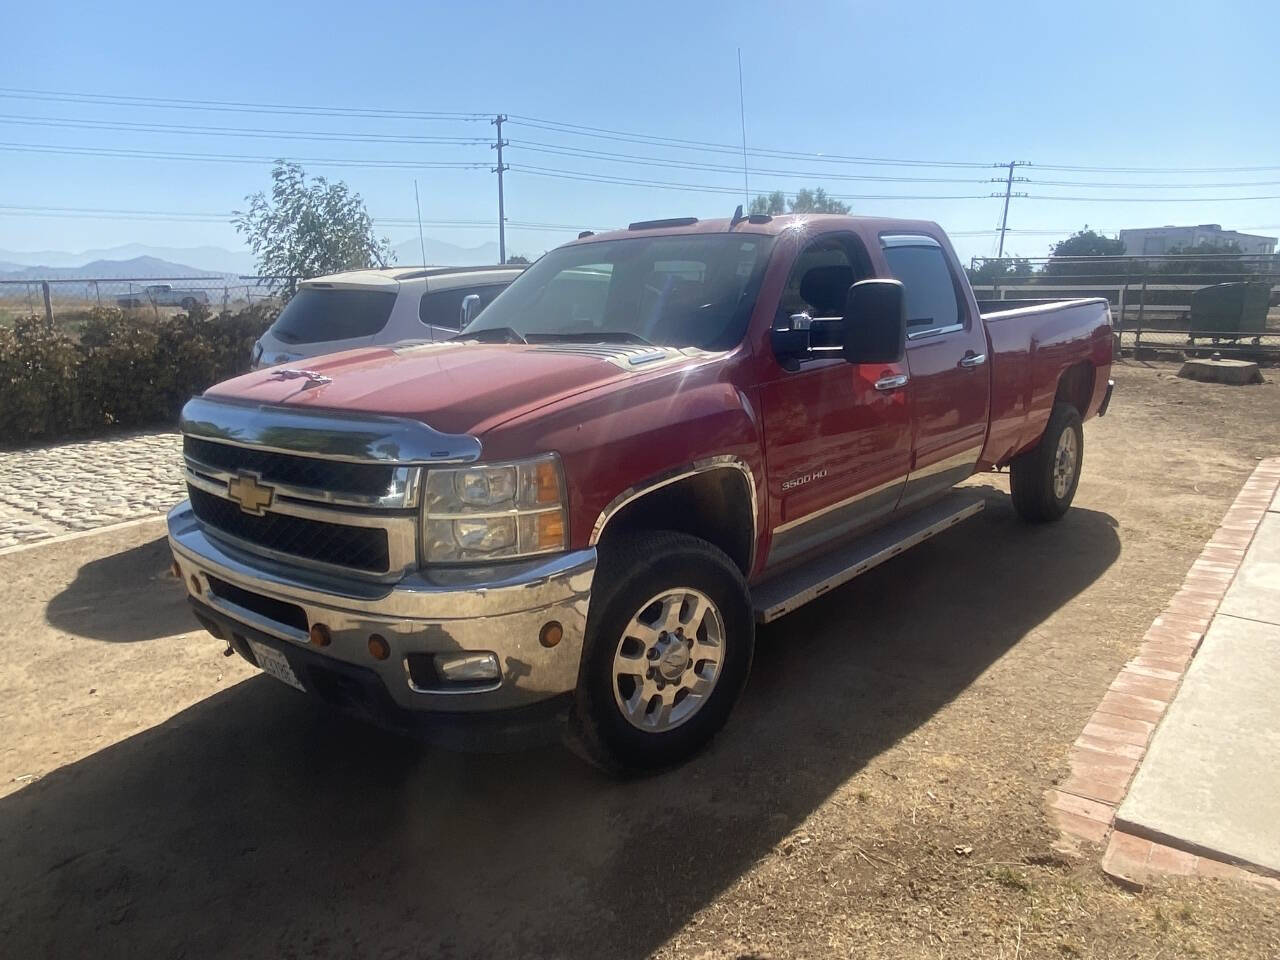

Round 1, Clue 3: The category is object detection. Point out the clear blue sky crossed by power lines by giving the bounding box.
[0,0,1280,267]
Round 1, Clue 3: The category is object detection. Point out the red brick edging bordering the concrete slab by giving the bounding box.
[1044,457,1280,890]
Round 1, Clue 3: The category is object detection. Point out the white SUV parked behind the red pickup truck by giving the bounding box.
[252,266,525,370]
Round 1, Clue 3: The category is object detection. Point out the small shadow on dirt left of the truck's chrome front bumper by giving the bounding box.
[45,536,197,643]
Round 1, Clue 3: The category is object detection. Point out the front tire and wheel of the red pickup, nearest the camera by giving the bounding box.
[568,532,755,776]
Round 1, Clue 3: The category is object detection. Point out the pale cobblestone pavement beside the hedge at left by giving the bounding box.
[0,431,186,549]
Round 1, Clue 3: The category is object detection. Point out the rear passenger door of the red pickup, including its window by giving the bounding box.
[881,233,991,507]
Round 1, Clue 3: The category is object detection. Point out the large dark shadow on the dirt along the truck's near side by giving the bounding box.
[0,488,1120,960]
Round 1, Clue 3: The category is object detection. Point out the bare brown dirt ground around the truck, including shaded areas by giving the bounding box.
[0,361,1280,960]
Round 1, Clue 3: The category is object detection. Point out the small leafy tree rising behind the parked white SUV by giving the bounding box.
[232,160,396,296]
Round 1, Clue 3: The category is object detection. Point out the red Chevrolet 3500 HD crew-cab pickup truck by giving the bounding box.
[169,212,1112,771]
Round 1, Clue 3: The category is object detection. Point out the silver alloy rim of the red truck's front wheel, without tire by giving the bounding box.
[613,586,724,733]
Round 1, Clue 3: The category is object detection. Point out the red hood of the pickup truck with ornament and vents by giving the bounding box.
[205,342,690,434]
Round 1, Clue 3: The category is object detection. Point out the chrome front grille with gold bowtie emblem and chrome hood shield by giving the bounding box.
[180,397,480,580]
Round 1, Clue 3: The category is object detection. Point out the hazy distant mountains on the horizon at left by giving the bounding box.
[0,237,509,280]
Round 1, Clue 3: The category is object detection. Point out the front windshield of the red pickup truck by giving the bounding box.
[462,233,773,351]
